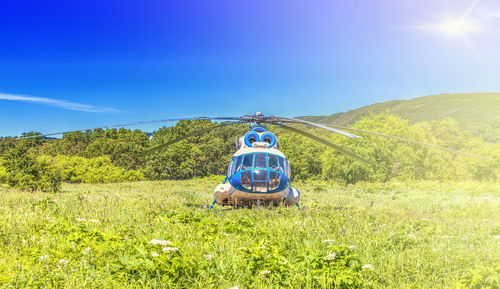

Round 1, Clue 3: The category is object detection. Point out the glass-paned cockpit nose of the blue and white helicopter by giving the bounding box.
[228,152,291,193]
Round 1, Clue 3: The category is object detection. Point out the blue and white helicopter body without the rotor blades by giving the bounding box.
[214,127,300,206]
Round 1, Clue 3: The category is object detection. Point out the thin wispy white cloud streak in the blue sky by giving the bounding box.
[0,93,121,113]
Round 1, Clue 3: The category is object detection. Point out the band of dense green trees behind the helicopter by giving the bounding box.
[0,112,500,191]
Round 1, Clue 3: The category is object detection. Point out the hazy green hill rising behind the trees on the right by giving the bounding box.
[300,93,500,142]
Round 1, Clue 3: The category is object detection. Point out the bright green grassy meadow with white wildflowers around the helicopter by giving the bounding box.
[0,180,500,288]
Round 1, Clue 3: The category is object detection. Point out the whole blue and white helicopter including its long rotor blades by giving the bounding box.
[16,112,492,210]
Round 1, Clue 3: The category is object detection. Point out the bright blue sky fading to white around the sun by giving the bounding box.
[0,0,500,136]
